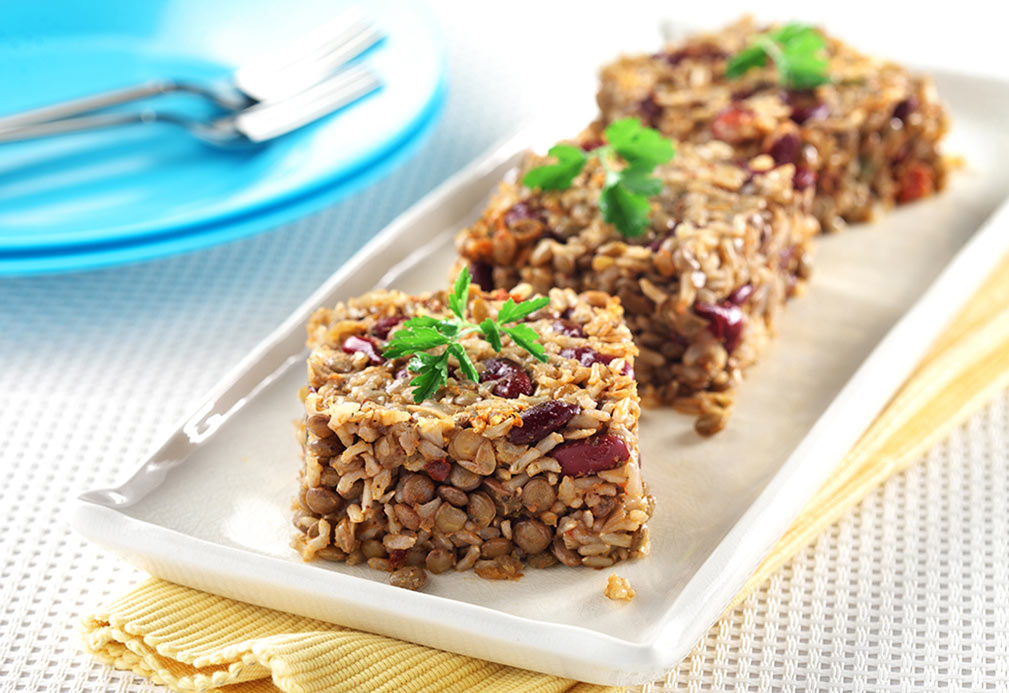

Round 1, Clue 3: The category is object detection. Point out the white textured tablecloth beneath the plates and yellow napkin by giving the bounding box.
[0,2,1009,692]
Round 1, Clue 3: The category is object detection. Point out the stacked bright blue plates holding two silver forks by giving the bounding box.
[0,0,444,274]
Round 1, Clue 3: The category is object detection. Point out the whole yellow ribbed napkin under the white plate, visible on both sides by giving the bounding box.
[84,260,1009,693]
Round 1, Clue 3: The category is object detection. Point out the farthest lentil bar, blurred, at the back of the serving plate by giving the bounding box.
[597,18,948,231]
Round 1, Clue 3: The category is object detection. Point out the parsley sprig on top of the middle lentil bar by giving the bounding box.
[522,118,676,237]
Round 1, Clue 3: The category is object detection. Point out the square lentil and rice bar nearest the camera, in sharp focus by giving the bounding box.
[294,285,653,588]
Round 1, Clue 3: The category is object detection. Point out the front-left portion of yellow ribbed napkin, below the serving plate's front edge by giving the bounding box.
[84,579,612,693]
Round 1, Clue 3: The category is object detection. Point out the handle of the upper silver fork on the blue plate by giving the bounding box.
[0,80,251,131]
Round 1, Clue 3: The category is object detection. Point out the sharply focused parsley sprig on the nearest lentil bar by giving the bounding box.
[382,267,550,405]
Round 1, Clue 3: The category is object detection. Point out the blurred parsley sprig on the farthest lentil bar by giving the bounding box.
[725,22,830,90]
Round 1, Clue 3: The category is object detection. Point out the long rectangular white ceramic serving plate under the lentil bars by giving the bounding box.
[73,67,1009,684]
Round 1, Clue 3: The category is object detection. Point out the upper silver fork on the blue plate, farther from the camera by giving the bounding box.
[0,9,382,131]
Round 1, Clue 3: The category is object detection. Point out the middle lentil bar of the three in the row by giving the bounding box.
[456,139,818,435]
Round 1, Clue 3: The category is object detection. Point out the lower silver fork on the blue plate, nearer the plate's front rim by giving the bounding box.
[0,66,380,146]
